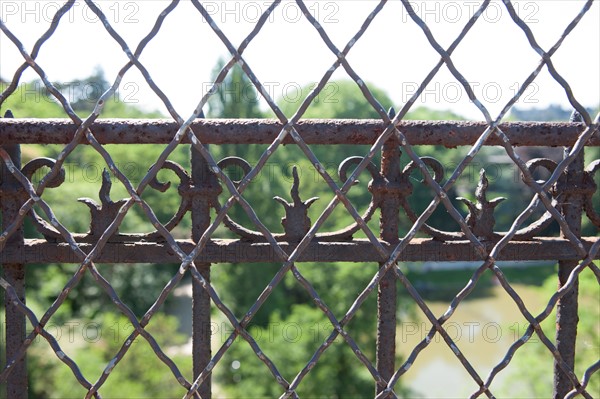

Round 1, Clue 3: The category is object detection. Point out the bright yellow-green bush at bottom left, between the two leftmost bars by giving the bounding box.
[29,313,192,399]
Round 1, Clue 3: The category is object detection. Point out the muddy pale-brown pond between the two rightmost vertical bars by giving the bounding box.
[397,264,554,398]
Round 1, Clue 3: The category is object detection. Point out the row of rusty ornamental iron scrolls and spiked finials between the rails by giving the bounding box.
[22,156,600,242]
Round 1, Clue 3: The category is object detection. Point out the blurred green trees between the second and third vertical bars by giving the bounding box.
[209,75,424,397]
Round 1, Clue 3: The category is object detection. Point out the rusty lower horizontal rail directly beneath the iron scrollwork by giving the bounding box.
[0,237,600,264]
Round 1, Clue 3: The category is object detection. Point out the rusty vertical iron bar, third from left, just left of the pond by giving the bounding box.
[376,130,400,393]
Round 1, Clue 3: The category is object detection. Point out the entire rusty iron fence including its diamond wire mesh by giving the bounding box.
[0,0,600,398]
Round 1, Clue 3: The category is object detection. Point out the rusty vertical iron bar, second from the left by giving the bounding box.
[191,146,218,399]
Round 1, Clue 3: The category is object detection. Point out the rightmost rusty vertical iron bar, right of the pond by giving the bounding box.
[554,113,585,399]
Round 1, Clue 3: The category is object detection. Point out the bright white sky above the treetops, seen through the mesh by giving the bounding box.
[0,0,600,119]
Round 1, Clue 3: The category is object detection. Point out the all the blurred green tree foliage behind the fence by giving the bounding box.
[1,60,598,397]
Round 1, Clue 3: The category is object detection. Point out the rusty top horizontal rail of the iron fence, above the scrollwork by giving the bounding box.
[0,119,600,147]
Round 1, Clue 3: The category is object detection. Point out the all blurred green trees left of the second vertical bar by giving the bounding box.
[0,70,191,398]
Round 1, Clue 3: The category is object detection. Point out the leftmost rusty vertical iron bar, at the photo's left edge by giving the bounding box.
[0,136,28,399]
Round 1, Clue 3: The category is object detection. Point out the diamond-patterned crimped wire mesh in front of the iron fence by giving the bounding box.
[0,0,600,398]
